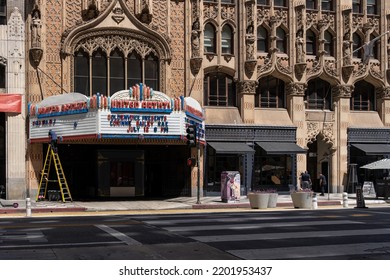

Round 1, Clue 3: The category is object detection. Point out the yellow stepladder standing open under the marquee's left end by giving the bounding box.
[36,145,72,202]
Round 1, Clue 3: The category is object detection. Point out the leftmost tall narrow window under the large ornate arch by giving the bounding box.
[74,51,90,96]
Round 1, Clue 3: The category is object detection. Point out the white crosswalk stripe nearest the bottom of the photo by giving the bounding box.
[227,242,390,260]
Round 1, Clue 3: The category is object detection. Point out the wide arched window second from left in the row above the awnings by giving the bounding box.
[255,76,285,108]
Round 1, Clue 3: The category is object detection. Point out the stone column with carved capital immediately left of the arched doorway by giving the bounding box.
[286,83,307,188]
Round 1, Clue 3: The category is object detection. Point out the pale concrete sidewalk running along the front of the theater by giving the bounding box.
[0,193,390,217]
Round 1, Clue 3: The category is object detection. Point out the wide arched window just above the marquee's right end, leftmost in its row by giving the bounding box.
[204,72,236,107]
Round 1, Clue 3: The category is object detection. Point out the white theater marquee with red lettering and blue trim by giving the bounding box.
[29,84,205,143]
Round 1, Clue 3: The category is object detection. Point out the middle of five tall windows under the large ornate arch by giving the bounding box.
[110,49,125,95]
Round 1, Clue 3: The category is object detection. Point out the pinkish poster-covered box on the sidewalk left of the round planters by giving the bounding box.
[221,171,241,203]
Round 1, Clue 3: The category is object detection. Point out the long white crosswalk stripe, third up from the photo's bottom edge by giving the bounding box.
[164,220,364,232]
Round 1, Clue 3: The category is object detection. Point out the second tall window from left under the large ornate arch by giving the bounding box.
[92,50,107,95]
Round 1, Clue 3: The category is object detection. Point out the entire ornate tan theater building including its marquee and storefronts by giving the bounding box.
[19,0,390,199]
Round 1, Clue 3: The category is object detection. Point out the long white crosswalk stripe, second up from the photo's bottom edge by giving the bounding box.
[190,228,390,243]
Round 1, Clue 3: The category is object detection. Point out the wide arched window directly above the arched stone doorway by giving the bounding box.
[305,78,332,110]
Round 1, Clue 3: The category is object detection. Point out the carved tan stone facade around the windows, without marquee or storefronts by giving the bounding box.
[16,0,390,201]
